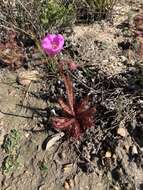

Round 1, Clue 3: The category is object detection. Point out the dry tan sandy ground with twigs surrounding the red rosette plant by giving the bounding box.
[0,0,143,190]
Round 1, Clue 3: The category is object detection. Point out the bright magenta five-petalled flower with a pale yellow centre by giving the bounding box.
[41,34,64,56]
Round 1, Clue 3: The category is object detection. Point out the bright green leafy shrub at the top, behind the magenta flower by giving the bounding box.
[40,0,74,30]
